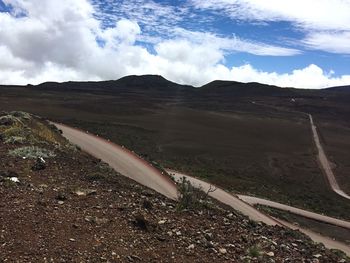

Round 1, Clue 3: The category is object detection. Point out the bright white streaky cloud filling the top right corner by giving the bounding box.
[191,0,350,30]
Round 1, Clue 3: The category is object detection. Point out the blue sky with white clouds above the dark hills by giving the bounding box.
[0,0,350,89]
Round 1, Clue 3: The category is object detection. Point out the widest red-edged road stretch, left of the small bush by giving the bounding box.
[53,123,177,200]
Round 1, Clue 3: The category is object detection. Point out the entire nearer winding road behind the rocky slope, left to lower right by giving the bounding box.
[53,123,350,256]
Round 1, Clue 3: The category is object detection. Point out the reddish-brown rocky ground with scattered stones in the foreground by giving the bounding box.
[0,112,349,263]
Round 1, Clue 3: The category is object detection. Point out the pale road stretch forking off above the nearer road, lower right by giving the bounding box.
[238,195,350,229]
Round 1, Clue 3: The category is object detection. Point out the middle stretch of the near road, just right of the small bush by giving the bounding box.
[166,169,280,225]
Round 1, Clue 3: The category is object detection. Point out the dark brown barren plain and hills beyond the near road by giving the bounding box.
[0,76,350,222]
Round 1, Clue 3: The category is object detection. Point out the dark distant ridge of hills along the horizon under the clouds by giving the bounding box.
[0,75,350,99]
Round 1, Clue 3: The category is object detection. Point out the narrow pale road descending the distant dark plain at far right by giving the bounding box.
[309,114,350,200]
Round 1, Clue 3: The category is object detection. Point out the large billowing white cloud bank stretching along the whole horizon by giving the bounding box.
[0,0,350,88]
